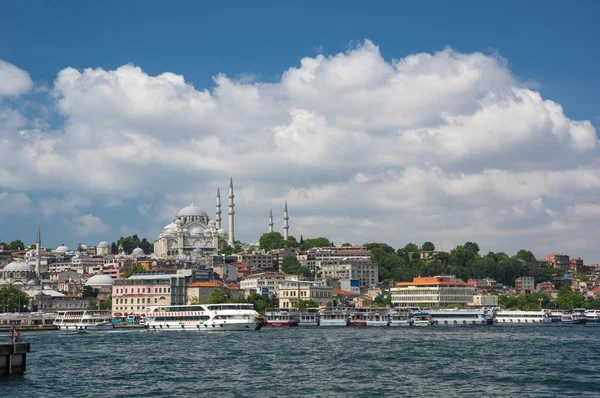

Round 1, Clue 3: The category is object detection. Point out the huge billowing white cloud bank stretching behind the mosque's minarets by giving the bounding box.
[0,41,600,256]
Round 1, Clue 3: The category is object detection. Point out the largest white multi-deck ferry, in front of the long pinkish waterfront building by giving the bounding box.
[145,303,264,331]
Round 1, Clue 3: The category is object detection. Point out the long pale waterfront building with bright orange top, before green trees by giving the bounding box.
[390,276,475,308]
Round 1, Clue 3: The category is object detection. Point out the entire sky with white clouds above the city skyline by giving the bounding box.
[0,1,600,263]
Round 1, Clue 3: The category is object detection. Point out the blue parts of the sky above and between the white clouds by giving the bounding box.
[0,1,600,261]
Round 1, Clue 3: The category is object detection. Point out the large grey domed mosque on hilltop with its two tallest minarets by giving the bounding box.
[154,179,235,257]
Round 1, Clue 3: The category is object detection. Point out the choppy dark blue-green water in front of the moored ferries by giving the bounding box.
[0,325,600,397]
